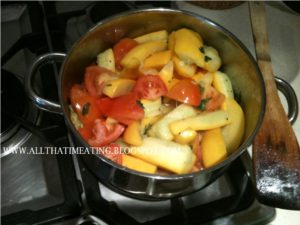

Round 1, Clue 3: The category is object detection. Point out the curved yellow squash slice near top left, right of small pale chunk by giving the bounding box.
[121,40,167,68]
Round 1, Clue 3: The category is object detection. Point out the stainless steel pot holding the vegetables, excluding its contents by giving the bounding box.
[26,9,295,200]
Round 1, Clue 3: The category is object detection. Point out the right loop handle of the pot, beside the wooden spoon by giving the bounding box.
[275,77,299,124]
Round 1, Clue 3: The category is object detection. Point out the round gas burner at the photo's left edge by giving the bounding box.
[0,69,38,157]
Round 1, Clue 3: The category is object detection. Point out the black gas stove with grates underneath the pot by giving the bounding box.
[1,1,298,225]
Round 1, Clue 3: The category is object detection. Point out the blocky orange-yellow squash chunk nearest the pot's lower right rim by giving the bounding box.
[201,128,227,168]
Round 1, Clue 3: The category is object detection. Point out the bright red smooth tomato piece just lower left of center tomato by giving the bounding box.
[97,92,144,125]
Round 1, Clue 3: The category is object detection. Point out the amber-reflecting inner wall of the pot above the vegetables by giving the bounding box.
[60,9,265,171]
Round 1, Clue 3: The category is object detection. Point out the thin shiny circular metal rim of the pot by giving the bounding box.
[58,8,266,180]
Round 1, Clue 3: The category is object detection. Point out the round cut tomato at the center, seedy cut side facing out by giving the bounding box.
[133,75,168,100]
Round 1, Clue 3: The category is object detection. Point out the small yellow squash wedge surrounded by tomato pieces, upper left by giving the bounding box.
[103,78,136,98]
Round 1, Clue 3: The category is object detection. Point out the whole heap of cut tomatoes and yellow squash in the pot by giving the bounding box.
[70,28,245,174]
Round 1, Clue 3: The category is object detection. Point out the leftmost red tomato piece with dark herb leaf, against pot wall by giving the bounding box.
[70,84,101,125]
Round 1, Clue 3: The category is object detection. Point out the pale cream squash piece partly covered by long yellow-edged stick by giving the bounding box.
[148,104,197,141]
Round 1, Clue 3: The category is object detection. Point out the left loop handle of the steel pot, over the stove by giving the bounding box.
[25,52,66,114]
